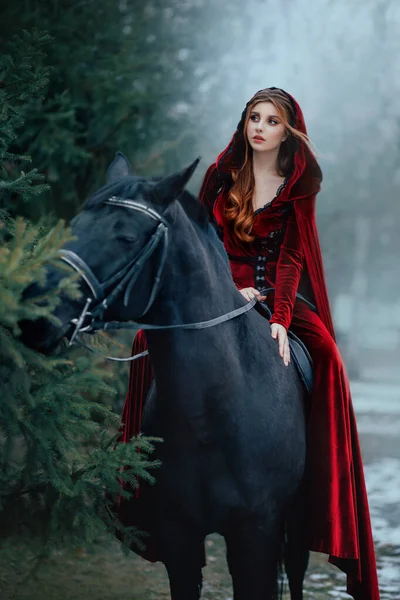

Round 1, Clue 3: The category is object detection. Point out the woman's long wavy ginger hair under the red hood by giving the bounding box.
[225,88,314,242]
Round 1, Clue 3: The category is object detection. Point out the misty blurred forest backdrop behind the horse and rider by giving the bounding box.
[0,0,400,354]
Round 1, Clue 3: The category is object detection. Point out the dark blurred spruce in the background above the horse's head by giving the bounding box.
[0,0,196,220]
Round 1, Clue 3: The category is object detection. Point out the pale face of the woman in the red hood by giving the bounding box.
[246,102,287,152]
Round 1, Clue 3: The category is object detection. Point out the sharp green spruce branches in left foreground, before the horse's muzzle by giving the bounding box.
[0,32,161,568]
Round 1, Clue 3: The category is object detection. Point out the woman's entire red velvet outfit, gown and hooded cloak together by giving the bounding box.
[117,86,379,600]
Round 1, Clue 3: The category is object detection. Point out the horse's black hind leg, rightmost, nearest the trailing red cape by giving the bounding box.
[284,497,310,600]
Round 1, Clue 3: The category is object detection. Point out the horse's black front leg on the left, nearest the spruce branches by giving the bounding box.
[159,521,204,600]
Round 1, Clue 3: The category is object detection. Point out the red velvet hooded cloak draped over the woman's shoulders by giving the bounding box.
[200,92,379,600]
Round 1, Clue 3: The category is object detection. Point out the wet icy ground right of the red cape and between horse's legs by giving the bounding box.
[127,381,400,600]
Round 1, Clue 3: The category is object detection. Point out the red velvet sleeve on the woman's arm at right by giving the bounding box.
[271,210,304,329]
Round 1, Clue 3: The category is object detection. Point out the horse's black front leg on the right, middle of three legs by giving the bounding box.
[224,518,281,600]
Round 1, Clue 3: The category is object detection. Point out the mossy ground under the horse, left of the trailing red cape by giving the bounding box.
[0,535,354,600]
